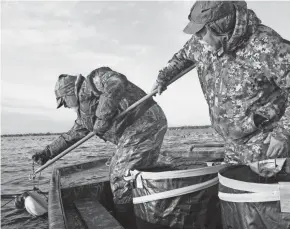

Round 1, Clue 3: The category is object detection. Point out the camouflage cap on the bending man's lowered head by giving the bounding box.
[54,74,77,108]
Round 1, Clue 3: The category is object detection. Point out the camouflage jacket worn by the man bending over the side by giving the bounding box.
[48,67,155,157]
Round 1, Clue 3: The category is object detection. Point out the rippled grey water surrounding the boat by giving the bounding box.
[1,130,217,229]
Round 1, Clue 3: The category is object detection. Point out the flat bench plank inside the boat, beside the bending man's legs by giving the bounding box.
[74,199,124,229]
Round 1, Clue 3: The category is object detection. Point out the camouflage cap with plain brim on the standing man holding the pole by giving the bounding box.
[183,1,235,34]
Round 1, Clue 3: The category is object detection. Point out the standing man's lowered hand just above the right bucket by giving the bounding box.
[264,133,288,158]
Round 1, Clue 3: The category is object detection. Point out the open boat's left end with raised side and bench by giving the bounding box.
[48,143,222,229]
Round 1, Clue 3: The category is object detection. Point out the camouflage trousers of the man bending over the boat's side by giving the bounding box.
[110,104,167,204]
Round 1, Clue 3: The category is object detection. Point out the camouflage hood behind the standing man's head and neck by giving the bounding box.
[225,2,261,51]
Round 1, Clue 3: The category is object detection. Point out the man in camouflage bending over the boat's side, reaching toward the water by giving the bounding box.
[33,67,167,226]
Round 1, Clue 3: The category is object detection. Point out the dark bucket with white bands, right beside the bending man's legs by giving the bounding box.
[126,163,225,229]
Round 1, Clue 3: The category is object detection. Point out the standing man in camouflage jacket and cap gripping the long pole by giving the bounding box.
[154,1,290,163]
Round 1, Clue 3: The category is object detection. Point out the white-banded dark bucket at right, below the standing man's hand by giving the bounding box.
[219,159,290,229]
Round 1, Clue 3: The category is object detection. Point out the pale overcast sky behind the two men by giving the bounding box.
[1,1,290,134]
